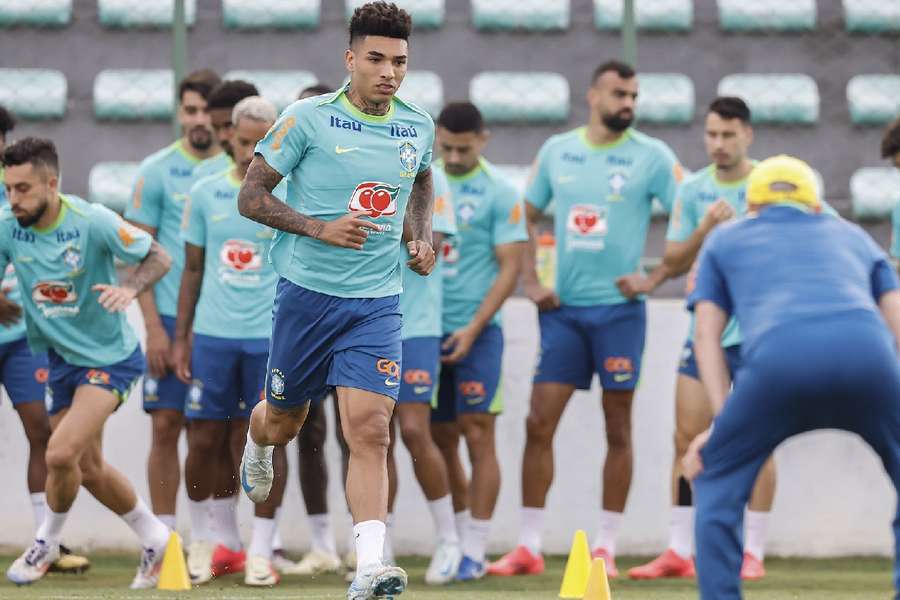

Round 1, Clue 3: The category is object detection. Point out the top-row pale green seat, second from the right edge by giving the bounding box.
[717,0,816,31]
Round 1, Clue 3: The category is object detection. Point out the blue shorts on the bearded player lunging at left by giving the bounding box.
[47,346,146,416]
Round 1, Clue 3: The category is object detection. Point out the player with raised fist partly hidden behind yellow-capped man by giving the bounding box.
[628,97,775,579]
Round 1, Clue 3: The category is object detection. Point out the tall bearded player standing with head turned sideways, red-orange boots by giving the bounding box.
[489,61,681,577]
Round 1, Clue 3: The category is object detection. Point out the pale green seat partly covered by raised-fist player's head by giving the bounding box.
[719,74,819,125]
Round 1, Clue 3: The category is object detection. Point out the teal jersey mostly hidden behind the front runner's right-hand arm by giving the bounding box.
[400,167,456,340]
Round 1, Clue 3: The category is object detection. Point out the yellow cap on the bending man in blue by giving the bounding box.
[747,154,820,208]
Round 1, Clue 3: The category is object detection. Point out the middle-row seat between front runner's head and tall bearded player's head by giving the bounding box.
[469,71,569,123]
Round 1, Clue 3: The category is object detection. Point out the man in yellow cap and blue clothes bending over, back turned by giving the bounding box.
[683,155,900,600]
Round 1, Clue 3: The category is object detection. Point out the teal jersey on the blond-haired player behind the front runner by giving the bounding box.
[182,170,278,339]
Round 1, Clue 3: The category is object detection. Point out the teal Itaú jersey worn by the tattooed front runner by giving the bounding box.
[256,88,434,298]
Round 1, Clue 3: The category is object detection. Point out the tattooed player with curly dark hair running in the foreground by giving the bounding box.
[238,2,435,600]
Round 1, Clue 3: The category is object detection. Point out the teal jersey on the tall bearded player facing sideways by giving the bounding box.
[525,127,681,306]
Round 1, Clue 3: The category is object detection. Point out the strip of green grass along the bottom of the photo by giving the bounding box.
[0,555,891,600]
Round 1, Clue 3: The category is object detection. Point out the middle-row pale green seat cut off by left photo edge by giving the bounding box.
[0,69,68,119]
